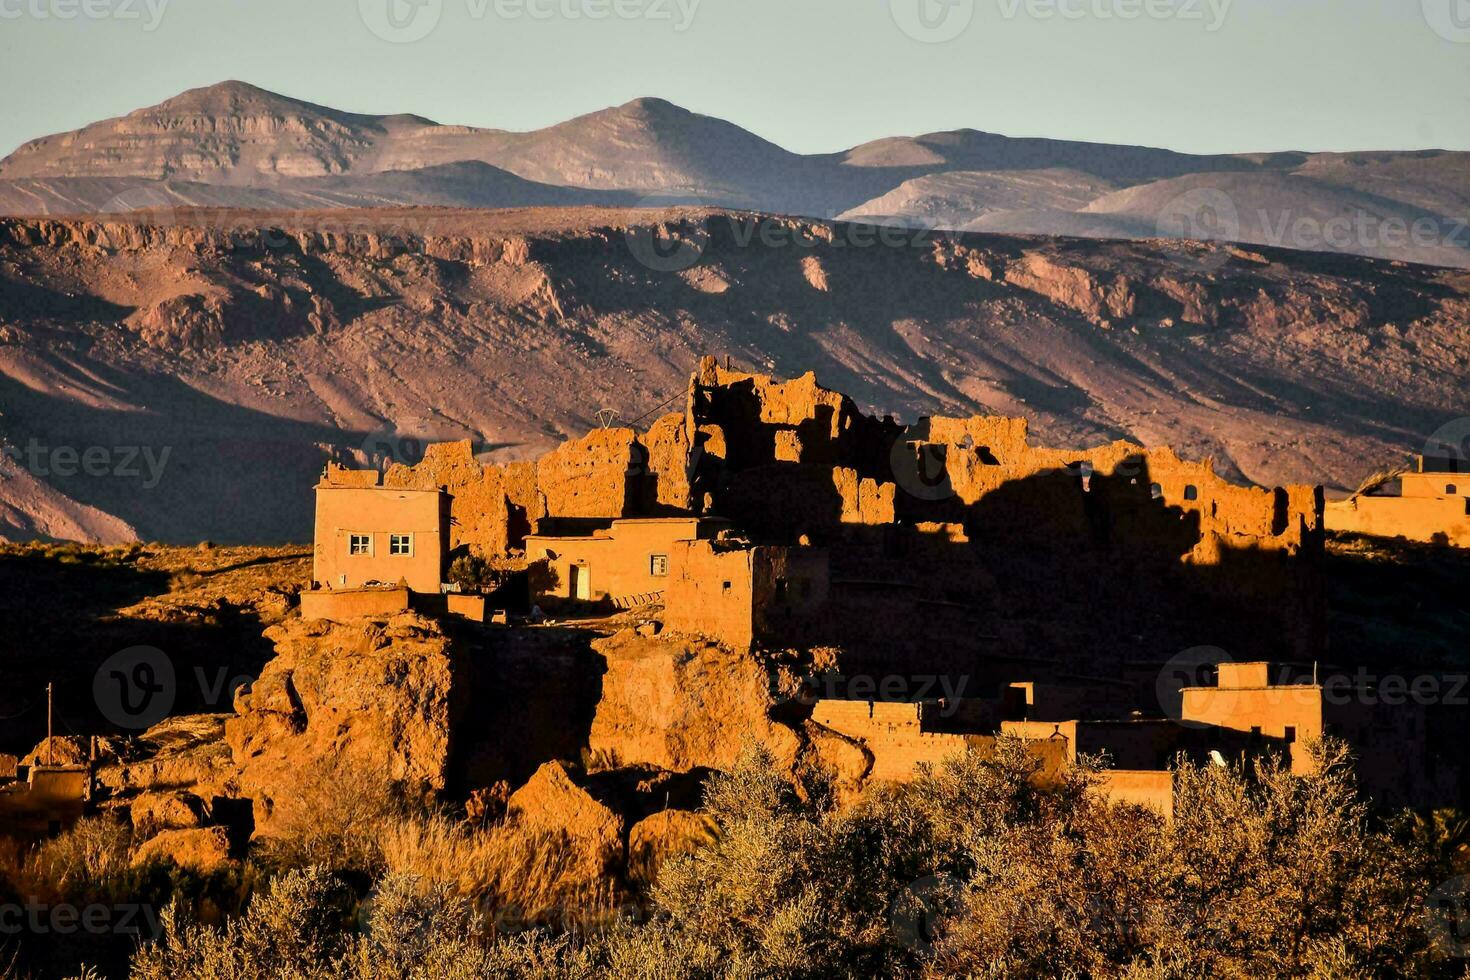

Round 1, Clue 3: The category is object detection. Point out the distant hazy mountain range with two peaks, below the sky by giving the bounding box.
[0,82,1470,267]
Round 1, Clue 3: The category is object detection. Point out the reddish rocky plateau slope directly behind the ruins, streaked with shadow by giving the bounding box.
[0,209,1470,541]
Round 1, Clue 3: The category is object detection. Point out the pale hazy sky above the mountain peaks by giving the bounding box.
[0,0,1470,153]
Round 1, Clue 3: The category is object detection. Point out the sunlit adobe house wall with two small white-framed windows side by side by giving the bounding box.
[312,481,447,594]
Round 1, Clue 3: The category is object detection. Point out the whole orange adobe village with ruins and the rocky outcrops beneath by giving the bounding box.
[0,357,1470,868]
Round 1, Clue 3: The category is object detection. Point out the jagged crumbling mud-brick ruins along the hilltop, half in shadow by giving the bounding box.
[361,359,1324,669]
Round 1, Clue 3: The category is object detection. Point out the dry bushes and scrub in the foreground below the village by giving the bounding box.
[4,741,1470,980]
